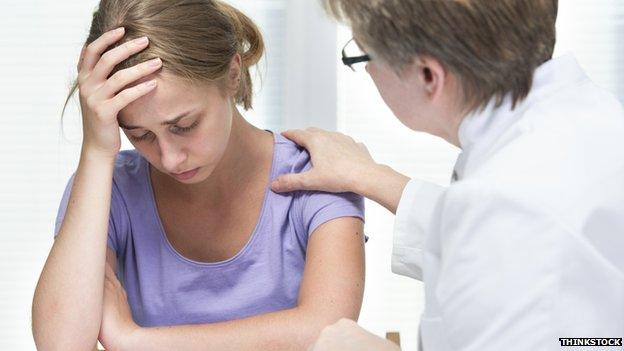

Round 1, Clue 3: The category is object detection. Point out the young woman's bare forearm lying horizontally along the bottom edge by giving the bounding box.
[129,308,342,351]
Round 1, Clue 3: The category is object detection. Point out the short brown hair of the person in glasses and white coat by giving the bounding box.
[323,0,558,110]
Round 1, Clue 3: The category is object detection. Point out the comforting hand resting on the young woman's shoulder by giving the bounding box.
[271,128,378,193]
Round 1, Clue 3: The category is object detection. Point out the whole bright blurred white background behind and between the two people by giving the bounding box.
[0,0,624,350]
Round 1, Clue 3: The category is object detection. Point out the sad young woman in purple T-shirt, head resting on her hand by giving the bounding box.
[33,0,364,350]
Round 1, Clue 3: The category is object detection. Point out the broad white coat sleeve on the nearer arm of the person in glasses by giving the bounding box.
[432,182,560,351]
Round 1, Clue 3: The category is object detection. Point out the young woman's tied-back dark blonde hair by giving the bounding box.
[63,0,264,116]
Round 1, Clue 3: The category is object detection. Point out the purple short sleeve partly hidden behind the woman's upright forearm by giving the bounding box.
[54,173,125,255]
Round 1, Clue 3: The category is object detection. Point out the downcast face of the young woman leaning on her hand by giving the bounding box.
[118,73,234,184]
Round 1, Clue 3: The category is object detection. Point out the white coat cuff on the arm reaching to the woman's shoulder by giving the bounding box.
[392,179,446,280]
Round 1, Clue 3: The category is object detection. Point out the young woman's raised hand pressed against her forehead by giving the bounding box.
[77,28,162,158]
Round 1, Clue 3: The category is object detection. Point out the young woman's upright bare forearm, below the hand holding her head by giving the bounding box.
[33,152,114,350]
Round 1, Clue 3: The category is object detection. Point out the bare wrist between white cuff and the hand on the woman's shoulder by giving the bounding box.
[353,165,410,214]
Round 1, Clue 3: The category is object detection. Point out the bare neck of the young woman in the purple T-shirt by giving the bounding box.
[152,108,273,207]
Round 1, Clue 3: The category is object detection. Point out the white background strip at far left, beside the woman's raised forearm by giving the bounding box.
[0,0,100,350]
